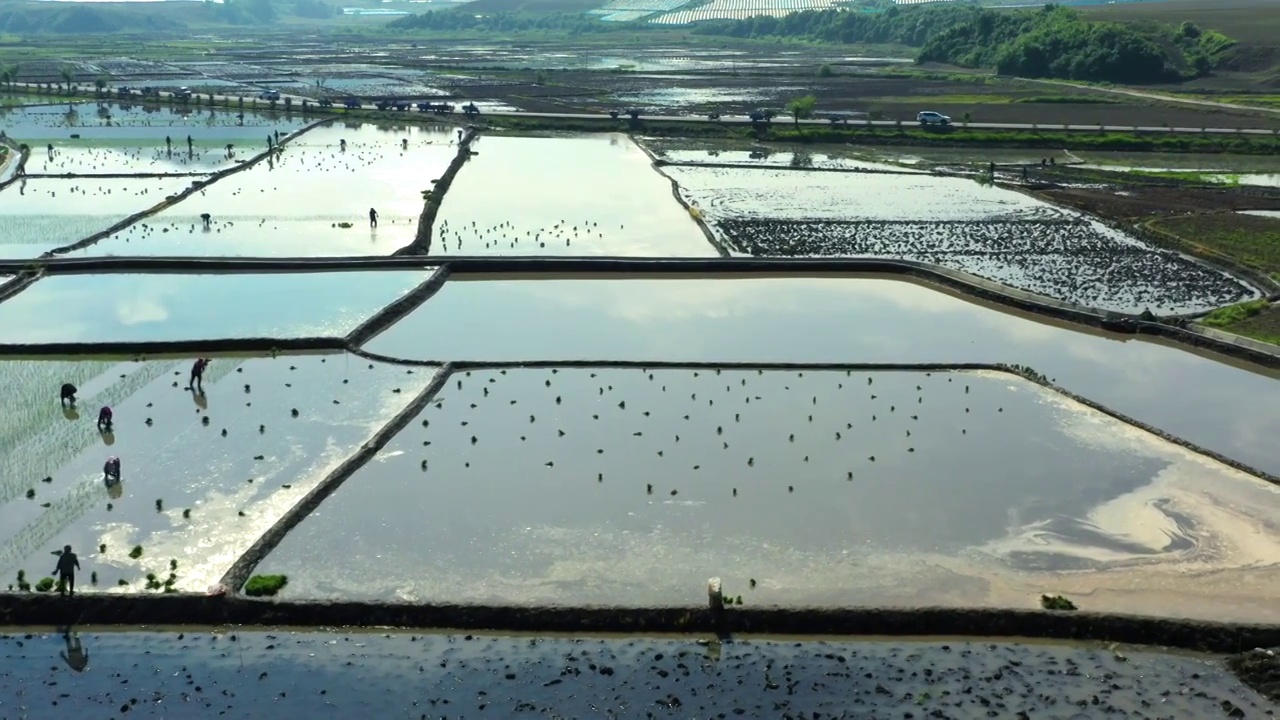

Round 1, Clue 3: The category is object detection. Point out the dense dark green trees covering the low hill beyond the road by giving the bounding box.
[692,3,1233,83]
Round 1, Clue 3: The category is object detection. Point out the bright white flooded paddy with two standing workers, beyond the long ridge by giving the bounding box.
[77,124,457,256]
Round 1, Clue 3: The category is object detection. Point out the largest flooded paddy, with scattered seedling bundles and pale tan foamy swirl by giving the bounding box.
[261,368,1280,621]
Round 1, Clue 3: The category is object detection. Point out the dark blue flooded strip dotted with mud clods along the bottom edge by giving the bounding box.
[0,628,1268,720]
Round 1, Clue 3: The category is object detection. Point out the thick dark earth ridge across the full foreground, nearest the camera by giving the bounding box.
[0,593,1280,653]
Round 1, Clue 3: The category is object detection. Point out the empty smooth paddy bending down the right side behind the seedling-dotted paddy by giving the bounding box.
[360,275,1280,474]
